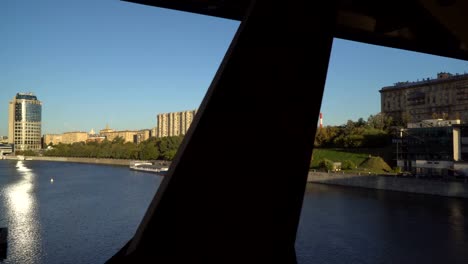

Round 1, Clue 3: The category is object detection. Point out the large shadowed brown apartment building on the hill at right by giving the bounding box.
[379,72,468,124]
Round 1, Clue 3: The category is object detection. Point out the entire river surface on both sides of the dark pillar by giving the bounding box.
[0,160,468,264]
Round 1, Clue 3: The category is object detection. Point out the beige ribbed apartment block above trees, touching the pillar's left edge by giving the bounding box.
[156,110,197,137]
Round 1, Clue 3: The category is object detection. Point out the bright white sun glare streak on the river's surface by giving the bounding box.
[5,161,40,263]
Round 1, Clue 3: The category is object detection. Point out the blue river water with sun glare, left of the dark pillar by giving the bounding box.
[0,160,161,264]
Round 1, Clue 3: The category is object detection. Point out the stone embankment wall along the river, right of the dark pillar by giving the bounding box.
[307,171,468,198]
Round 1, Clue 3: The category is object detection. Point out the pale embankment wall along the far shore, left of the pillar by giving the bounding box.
[5,156,170,167]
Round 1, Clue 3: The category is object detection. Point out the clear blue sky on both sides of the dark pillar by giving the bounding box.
[0,0,468,135]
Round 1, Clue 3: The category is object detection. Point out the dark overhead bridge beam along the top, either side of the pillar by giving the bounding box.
[125,0,468,60]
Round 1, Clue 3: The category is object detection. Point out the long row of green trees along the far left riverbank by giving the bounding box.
[39,136,184,160]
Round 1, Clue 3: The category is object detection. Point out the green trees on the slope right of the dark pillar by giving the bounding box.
[314,113,394,148]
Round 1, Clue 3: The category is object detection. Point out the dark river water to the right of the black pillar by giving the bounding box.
[296,184,468,264]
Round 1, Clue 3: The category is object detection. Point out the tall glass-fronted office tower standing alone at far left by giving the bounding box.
[8,93,42,150]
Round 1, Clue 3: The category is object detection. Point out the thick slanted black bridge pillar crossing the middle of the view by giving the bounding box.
[108,0,335,263]
